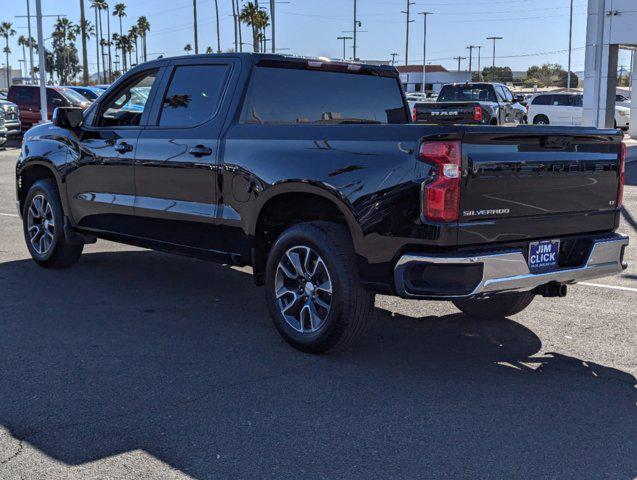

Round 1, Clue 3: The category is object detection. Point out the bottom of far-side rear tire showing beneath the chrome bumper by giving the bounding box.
[453,292,535,320]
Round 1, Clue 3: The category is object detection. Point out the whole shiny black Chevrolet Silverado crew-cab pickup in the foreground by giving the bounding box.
[16,54,628,352]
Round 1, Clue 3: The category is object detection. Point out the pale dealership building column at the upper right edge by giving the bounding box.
[583,0,637,138]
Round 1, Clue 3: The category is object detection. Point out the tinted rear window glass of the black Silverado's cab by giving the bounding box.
[241,67,408,124]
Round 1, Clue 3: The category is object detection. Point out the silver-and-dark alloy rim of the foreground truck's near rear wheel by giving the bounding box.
[274,246,332,333]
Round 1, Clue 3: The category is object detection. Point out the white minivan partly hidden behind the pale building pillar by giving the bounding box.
[528,92,630,130]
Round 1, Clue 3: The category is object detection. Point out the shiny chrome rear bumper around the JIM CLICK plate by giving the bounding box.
[394,234,628,298]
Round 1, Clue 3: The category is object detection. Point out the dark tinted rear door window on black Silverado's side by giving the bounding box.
[159,65,228,127]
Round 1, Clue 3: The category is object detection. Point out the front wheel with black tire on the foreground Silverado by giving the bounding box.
[22,179,84,268]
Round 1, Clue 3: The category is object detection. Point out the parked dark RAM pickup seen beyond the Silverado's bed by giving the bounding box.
[412,83,527,125]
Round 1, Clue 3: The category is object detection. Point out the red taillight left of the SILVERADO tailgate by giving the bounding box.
[420,141,461,222]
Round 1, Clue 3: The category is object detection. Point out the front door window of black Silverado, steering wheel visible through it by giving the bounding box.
[97,70,157,127]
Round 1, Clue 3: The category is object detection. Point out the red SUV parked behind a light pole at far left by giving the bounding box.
[8,85,90,131]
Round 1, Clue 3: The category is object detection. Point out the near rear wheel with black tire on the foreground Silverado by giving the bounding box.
[265,221,374,353]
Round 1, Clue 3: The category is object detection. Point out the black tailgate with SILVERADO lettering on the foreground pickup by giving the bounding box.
[459,126,623,244]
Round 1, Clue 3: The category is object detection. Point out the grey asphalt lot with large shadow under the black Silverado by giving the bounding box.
[0,140,637,480]
